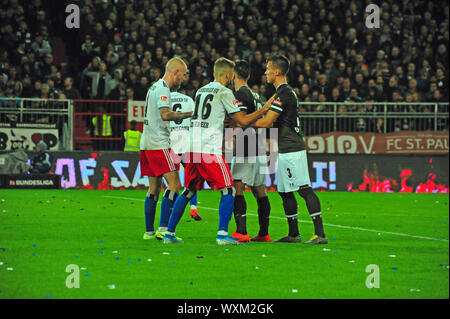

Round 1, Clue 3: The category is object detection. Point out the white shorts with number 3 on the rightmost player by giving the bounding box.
[277,150,311,193]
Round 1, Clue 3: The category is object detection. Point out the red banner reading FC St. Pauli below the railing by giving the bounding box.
[306,131,449,154]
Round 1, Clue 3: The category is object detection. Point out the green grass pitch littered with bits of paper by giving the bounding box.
[0,190,449,299]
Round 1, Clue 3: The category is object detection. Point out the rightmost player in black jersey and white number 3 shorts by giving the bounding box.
[252,54,328,244]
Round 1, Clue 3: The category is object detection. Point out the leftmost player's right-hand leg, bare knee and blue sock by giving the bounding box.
[157,171,181,239]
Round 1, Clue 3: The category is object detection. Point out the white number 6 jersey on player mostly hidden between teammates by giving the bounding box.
[170,92,194,154]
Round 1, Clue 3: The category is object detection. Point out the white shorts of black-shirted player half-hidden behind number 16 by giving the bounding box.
[231,155,267,187]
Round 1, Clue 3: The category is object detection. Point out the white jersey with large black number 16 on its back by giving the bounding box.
[189,82,240,155]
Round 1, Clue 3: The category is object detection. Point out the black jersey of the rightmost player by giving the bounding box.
[270,83,306,153]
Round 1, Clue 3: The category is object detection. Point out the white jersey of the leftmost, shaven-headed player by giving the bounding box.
[141,79,172,150]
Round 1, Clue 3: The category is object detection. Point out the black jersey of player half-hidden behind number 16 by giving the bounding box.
[234,85,266,157]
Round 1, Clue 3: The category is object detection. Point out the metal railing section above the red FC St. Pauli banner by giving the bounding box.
[299,102,449,136]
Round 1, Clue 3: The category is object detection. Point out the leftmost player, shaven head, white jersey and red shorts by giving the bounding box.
[140,57,192,239]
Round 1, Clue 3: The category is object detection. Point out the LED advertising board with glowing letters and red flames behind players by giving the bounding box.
[7,151,449,193]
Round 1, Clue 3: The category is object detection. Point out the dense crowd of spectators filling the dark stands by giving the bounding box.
[0,0,449,129]
